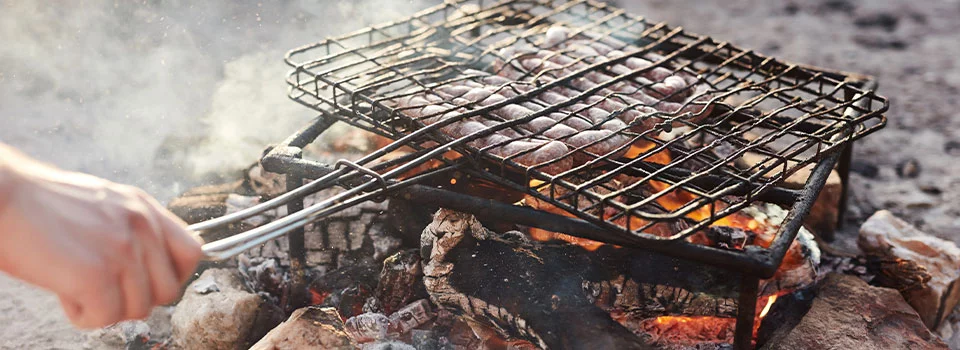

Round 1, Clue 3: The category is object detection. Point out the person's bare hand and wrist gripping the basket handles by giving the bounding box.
[0,144,202,328]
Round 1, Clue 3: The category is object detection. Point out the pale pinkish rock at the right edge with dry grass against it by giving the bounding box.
[857,210,960,329]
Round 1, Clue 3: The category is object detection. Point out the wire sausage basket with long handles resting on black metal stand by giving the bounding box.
[184,0,887,348]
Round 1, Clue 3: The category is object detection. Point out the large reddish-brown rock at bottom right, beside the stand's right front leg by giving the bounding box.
[763,274,947,349]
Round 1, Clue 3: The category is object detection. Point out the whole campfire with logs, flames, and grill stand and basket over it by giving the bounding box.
[142,0,928,349]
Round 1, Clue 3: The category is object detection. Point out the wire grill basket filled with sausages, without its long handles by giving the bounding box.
[287,0,887,240]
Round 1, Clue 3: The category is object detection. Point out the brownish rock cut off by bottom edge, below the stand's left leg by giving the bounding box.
[250,306,356,350]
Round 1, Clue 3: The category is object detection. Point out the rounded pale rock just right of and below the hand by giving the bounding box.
[171,269,263,350]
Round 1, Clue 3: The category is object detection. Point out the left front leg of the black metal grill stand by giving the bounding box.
[286,175,307,312]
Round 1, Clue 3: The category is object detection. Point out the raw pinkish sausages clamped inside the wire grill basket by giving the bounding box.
[395,27,708,174]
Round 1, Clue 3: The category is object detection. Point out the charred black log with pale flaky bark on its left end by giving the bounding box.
[421,210,646,349]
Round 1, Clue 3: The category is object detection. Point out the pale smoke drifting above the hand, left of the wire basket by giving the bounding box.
[0,0,435,199]
